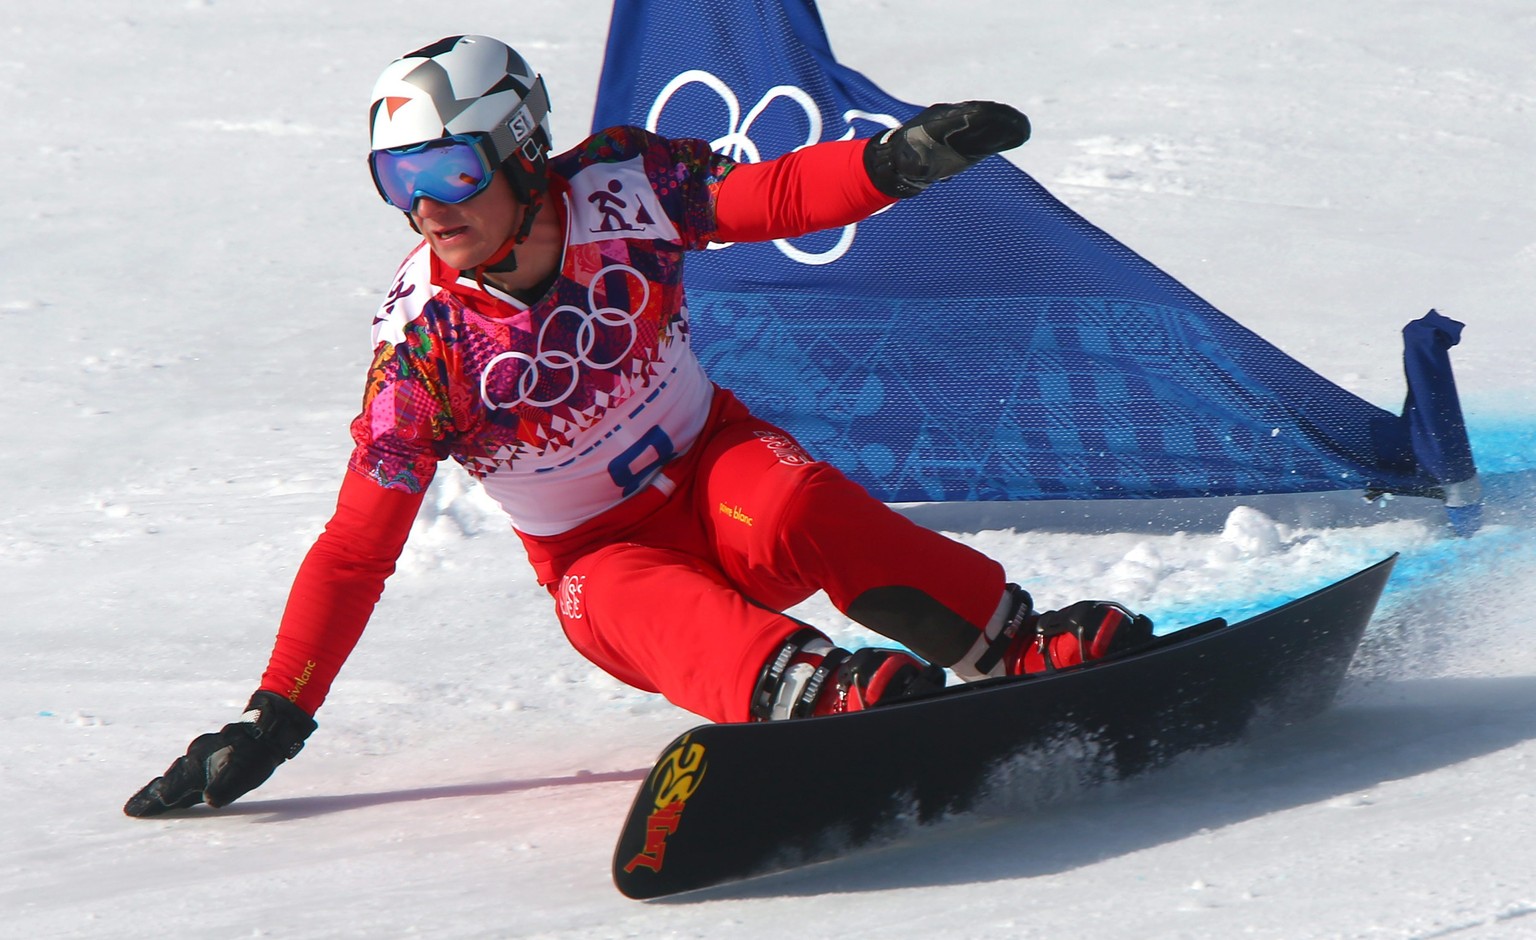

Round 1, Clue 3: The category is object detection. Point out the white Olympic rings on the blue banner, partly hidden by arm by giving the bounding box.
[645,69,902,264]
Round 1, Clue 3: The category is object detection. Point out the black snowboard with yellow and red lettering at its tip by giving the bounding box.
[613,556,1396,899]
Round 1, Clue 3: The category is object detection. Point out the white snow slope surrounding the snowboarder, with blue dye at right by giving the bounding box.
[9,0,1536,940]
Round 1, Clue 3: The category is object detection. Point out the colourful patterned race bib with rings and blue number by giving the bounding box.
[350,127,733,536]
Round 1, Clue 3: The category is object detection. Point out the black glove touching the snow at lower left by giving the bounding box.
[123,691,316,817]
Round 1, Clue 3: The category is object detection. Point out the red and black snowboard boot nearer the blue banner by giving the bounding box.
[952,584,1152,680]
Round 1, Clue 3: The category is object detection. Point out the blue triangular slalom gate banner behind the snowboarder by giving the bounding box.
[593,0,1476,525]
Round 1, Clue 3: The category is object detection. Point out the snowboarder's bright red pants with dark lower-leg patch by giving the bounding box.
[522,390,1003,722]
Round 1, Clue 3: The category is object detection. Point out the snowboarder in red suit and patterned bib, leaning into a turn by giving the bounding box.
[124,35,1150,816]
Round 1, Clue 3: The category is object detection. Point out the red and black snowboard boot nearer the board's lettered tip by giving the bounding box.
[751,627,945,722]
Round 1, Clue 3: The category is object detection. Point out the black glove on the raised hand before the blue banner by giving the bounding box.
[865,101,1029,198]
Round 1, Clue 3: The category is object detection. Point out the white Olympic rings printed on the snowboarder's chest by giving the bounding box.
[481,264,651,410]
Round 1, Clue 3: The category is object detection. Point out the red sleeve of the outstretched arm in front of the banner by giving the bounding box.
[714,140,895,241]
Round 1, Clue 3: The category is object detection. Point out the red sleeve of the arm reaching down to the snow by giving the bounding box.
[261,472,422,714]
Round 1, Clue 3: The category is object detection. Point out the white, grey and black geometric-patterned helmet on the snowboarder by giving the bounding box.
[369,35,551,163]
